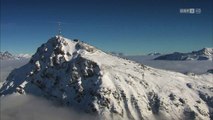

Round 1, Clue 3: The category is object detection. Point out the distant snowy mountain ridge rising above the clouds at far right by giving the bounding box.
[155,48,213,60]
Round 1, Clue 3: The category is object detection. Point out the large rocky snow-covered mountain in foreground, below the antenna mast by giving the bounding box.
[0,36,213,120]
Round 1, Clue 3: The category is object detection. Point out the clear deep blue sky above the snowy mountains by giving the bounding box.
[1,0,213,55]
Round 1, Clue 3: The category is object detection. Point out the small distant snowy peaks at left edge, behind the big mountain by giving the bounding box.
[0,51,31,60]
